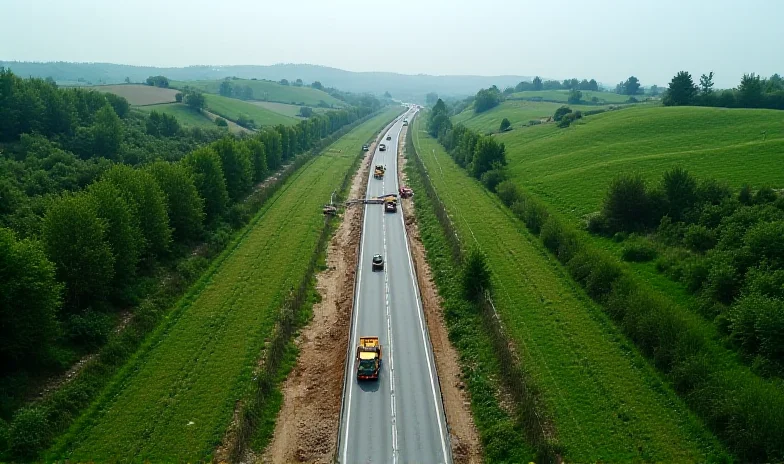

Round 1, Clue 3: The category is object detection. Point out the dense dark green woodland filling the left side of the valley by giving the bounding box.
[0,70,375,432]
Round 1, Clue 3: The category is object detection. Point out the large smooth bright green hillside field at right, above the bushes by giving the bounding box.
[496,107,784,219]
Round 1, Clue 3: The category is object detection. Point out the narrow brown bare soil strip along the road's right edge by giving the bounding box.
[397,127,482,464]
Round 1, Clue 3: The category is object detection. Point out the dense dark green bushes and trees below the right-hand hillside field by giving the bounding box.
[589,167,784,376]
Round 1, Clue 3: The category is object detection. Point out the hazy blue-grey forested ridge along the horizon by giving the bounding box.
[0,61,531,101]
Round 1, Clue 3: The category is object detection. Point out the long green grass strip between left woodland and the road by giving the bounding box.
[48,108,398,462]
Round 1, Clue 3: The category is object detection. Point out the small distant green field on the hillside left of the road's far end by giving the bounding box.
[170,79,346,107]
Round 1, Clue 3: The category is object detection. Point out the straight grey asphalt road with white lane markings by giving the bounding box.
[338,111,452,464]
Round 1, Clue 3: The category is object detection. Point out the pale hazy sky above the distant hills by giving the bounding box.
[0,0,784,87]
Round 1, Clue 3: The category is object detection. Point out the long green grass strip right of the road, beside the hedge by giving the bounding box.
[414,118,722,462]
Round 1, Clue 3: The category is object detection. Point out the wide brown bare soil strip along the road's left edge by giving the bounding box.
[261,139,375,463]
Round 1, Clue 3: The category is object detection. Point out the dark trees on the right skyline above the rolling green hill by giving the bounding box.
[662,71,784,110]
